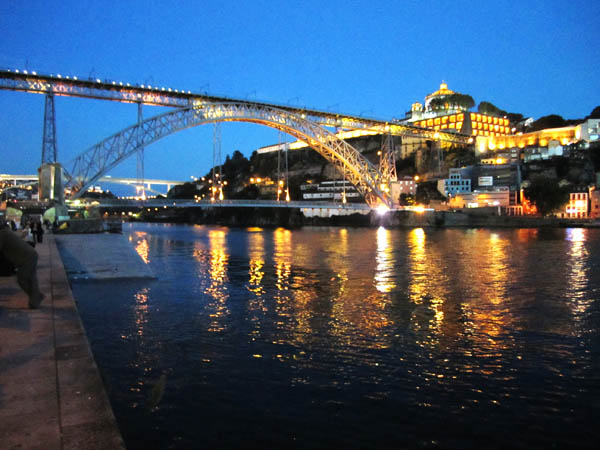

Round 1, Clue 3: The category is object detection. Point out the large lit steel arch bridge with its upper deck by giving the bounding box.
[0,70,471,207]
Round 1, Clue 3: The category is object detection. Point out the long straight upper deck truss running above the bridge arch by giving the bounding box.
[0,70,472,145]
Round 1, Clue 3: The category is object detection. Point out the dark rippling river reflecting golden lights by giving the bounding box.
[73,225,600,449]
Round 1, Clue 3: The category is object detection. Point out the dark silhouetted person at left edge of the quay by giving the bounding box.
[0,224,44,309]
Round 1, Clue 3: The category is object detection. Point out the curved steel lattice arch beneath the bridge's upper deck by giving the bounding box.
[68,102,392,207]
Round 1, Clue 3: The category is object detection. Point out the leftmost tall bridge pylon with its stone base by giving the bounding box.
[38,92,65,205]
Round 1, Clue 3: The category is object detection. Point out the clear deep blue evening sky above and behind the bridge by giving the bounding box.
[0,0,600,189]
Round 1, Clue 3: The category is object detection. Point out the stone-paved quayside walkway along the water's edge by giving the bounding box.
[0,234,125,450]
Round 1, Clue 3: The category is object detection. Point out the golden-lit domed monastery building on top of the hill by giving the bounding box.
[405,83,512,136]
